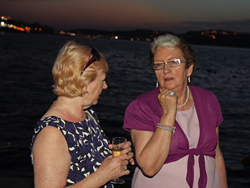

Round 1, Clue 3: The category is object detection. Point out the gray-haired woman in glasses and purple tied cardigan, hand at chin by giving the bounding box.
[123,35,227,188]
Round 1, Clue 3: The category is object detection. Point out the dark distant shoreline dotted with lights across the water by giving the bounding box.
[0,16,250,48]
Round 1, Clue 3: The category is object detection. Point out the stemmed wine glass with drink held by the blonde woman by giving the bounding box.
[110,137,127,184]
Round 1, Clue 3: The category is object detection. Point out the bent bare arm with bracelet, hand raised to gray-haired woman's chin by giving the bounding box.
[131,90,177,177]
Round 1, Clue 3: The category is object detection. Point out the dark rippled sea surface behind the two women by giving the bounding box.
[0,32,250,188]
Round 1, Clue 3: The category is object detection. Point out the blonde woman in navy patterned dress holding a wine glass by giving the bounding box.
[31,42,134,188]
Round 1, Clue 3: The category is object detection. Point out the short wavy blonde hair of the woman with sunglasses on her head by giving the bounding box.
[52,41,108,98]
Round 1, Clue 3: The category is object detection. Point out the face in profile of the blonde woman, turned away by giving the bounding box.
[84,70,108,106]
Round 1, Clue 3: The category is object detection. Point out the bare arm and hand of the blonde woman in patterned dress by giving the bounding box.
[32,126,133,188]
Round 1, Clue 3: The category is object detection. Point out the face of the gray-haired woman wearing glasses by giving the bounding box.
[154,48,193,91]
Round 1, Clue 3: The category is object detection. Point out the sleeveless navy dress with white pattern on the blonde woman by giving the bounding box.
[31,109,113,188]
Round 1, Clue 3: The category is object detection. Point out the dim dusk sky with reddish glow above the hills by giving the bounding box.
[0,0,250,33]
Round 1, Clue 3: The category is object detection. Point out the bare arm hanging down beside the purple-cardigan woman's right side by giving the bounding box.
[215,127,228,188]
